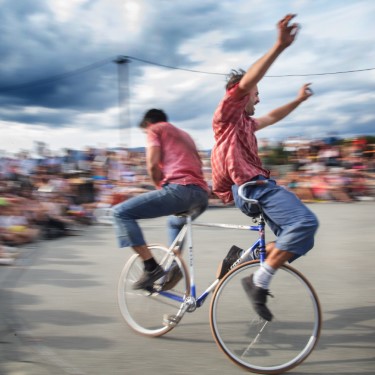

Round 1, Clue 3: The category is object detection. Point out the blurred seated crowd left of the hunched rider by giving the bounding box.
[0,149,154,264]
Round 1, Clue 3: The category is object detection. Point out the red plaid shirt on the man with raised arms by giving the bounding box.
[211,86,270,203]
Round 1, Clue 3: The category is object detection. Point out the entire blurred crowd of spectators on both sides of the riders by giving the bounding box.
[0,139,375,265]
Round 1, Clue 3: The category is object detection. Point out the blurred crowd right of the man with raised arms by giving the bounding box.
[261,138,375,203]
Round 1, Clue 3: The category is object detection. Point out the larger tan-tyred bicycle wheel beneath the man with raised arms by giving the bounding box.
[210,261,322,374]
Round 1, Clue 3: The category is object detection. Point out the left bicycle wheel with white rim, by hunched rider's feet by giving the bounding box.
[117,245,190,336]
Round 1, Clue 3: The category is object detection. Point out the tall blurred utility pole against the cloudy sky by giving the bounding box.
[114,56,131,148]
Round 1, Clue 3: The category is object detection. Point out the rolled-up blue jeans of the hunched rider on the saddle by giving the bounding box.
[113,184,208,247]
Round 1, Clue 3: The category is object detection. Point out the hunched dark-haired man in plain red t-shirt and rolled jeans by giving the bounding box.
[113,109,209,289]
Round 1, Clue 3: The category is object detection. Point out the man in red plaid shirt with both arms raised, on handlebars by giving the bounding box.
[211,14,318,320]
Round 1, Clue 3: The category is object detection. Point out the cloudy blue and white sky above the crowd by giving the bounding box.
[0,0,375,156]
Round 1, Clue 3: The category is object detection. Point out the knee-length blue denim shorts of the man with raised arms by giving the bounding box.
[232,176,319,262]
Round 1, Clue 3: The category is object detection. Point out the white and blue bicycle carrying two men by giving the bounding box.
[118,180,322,374]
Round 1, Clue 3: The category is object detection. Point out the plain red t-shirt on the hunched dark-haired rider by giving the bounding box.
[147,122,209,192]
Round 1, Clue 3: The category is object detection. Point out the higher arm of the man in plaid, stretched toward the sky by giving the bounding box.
[235,14,298,98]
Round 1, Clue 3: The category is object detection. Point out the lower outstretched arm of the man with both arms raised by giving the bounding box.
[256,83,313,130]
